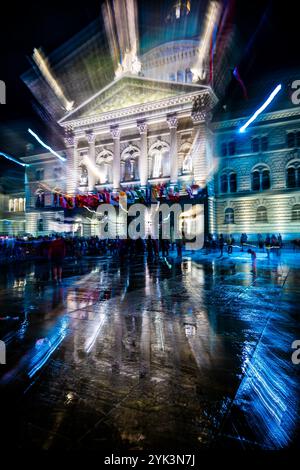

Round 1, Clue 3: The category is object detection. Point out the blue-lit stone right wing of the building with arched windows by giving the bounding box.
[212,90,300,239]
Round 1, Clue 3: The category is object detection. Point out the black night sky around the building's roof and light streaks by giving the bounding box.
[0,0,300,184]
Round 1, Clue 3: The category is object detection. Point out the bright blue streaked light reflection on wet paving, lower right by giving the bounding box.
[235,325,298,449]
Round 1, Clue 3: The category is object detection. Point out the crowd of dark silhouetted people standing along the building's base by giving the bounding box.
[0,233,300,264]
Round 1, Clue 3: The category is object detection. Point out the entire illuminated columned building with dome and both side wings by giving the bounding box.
[19,0,300,242]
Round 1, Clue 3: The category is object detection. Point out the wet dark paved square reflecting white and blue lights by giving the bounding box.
[0,254,300,451]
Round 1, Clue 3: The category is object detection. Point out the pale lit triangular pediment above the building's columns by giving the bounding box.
[60,76,207,122]
